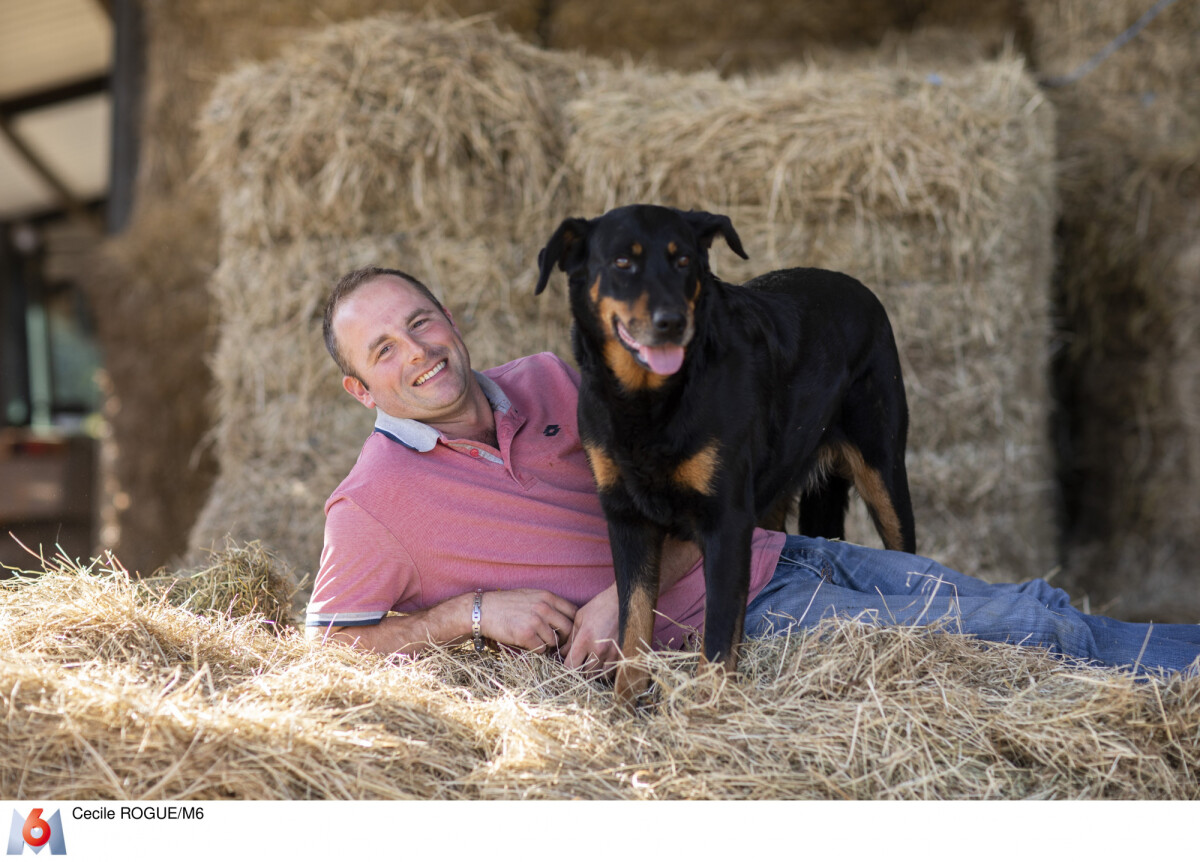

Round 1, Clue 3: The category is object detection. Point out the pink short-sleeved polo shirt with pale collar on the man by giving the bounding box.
[307,353,785,647]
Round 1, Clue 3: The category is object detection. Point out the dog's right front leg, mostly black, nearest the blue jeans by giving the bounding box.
[702,521,754,672]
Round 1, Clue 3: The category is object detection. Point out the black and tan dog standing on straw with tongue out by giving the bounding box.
[538,205,916,704]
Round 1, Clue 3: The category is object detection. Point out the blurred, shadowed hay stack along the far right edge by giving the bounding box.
[1030,0,1200,622]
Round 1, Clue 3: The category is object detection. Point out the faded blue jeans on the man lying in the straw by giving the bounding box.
[745,535,1200,671]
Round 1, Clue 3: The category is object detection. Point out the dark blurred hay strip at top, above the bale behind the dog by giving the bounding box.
[545,0,1028,73]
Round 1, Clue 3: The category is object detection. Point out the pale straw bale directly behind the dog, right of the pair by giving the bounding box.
[556,56,1055,580]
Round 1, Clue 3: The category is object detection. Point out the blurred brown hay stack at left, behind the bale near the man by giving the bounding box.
[85,0,540,581]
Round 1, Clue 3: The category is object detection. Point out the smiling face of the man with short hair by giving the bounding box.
[334,275,474,426]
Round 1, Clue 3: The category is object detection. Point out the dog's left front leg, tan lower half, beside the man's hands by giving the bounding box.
[608,516,666,706]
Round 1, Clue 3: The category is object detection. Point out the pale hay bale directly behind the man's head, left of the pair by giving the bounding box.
[192,14,600,571]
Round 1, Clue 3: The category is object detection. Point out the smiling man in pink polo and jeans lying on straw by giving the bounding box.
[307,268,1200,671]
